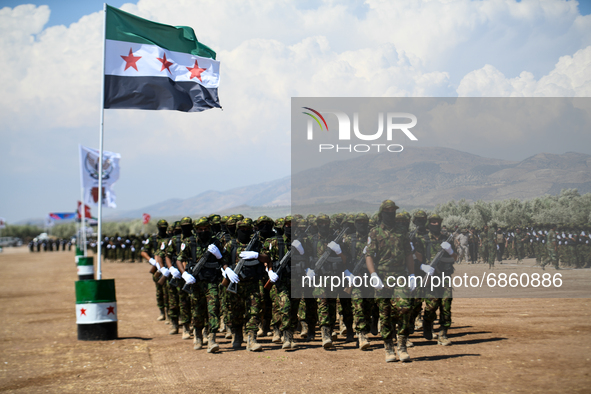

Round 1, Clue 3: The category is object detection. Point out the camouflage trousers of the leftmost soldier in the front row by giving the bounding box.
[191,281,220,332]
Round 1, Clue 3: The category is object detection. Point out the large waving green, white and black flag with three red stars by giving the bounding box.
[104,5,221,112]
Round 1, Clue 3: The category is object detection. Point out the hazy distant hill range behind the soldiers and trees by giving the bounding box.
[41,147,591,221]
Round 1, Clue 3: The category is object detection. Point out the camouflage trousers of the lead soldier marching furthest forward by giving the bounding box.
[376,287,412,340]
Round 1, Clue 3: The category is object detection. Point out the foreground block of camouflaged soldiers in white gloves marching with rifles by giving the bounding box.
[142,200,457,362]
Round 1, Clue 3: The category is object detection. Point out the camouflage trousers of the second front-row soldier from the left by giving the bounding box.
[227,278,262,332]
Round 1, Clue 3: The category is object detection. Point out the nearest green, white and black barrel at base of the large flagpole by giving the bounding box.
[76,279,117,341]
